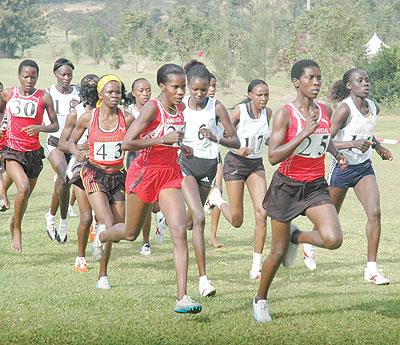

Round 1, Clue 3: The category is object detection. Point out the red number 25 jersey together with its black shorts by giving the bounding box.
[263,103,332,223]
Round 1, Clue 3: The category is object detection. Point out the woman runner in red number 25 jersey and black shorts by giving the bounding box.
[253,60,347,322]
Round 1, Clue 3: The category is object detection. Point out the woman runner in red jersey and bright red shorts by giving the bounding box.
[94,64,202,313]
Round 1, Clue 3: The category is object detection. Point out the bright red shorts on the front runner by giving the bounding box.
[125,162,183,203]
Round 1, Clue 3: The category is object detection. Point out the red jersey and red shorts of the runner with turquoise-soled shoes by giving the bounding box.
[125,100,184,203]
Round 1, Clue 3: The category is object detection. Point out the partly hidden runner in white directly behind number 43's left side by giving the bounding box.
[58,74,99,273]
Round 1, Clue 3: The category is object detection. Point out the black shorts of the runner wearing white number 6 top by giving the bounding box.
[179,154,218,187]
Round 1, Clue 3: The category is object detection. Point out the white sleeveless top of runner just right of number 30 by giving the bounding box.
[45,84,80,138]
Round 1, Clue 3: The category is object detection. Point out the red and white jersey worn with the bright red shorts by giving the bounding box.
[135,99,185,166]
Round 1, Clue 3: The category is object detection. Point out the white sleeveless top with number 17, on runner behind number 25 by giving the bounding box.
[231,103,270,159]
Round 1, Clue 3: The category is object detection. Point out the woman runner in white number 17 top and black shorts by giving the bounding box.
[209,79,272,279]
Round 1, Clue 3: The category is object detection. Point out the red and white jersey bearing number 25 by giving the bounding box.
[279,103,331,182]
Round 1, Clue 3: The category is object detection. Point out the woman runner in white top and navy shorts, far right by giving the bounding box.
[304,68,393,285]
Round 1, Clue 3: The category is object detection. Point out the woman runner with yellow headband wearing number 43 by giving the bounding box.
[68,74,133,289]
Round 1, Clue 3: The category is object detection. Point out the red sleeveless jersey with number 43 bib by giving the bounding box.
[89,108,126,167]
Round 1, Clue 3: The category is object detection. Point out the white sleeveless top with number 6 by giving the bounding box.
[183,97,219,159]
